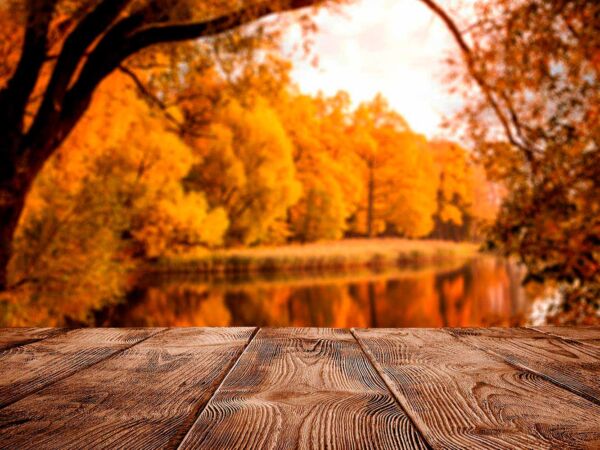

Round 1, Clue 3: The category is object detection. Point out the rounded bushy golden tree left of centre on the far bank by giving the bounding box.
[186,100,301,245]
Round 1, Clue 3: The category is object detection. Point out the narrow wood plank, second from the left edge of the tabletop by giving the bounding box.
[0,328,163,408]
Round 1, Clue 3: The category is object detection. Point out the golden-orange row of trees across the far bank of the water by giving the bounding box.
[5,57,498,310]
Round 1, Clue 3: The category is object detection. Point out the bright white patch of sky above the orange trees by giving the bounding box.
[288,0,460,138]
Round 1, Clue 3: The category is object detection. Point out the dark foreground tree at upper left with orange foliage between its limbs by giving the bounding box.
[0,0,332,290]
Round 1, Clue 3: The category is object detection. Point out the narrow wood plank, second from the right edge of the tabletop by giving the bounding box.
[450,328,600,405]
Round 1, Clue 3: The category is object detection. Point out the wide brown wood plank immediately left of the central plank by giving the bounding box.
[0,328,254,449]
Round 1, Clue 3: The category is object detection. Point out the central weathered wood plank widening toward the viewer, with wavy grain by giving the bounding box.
[181,329,426,449]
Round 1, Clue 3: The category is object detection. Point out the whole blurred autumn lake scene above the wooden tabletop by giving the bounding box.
[0,0,600,327]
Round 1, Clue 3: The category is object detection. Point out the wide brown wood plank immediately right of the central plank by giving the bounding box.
[353,329,600,449]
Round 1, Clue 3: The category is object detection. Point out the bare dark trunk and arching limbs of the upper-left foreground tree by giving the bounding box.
[0,0,319,292]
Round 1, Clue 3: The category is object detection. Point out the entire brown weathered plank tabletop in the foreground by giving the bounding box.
[0,327,600,449]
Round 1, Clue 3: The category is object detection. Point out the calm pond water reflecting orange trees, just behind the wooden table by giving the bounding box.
[95,257,529,327]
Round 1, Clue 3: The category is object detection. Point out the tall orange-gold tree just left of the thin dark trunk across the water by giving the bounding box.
[276,91,364,242]
